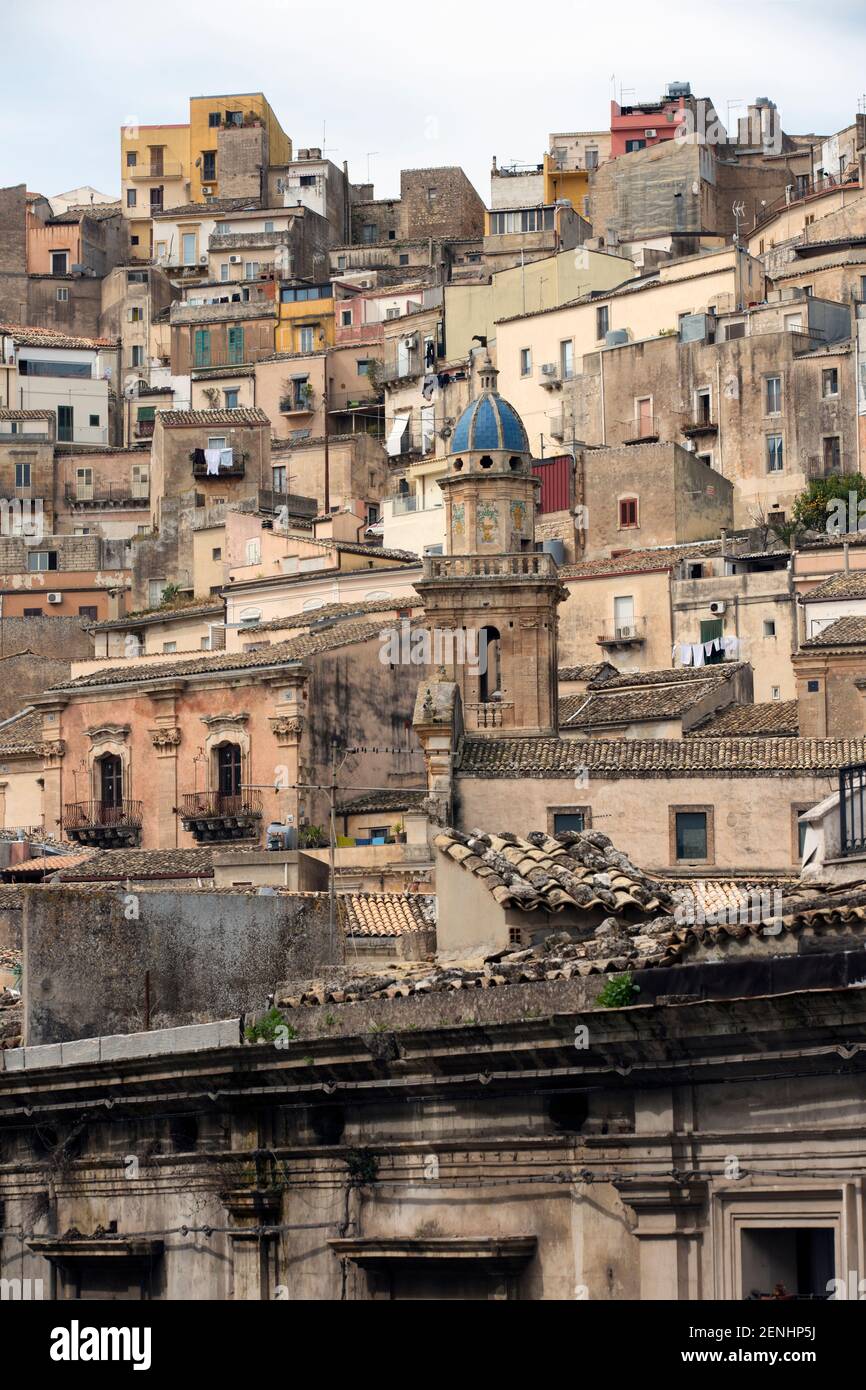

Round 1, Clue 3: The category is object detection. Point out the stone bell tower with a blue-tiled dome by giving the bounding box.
[416,359,566,735]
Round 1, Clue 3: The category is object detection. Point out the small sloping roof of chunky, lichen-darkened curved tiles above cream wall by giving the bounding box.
[434,830,673,917]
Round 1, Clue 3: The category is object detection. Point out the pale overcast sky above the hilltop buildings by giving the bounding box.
[0,0,866,202]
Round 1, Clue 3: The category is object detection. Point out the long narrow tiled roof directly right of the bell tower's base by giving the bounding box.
[457,738,866,778]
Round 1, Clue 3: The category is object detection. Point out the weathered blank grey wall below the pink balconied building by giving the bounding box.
[24,885,331,1045]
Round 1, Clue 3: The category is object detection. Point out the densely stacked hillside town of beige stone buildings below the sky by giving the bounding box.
[0,72,866,1302]
